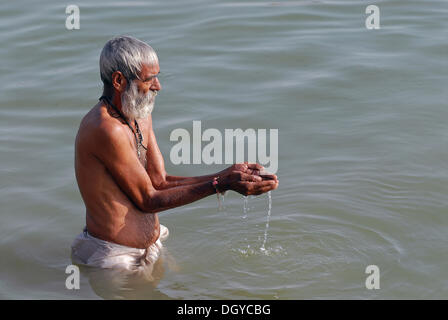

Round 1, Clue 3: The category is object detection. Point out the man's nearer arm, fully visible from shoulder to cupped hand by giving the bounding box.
[94,125,278,213]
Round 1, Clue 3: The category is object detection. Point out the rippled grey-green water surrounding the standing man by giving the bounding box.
[0,0,448,299]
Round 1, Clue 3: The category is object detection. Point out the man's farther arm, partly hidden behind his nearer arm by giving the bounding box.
[146,116,277,190]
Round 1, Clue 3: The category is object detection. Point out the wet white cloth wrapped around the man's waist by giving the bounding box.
[72,225,169,271]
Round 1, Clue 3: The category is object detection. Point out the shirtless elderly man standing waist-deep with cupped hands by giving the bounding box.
[72,36,278,270]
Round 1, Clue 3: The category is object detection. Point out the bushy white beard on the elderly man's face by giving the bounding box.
[121,81,157,119]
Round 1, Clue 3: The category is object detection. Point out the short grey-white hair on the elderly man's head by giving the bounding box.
[100,36,159,86]
